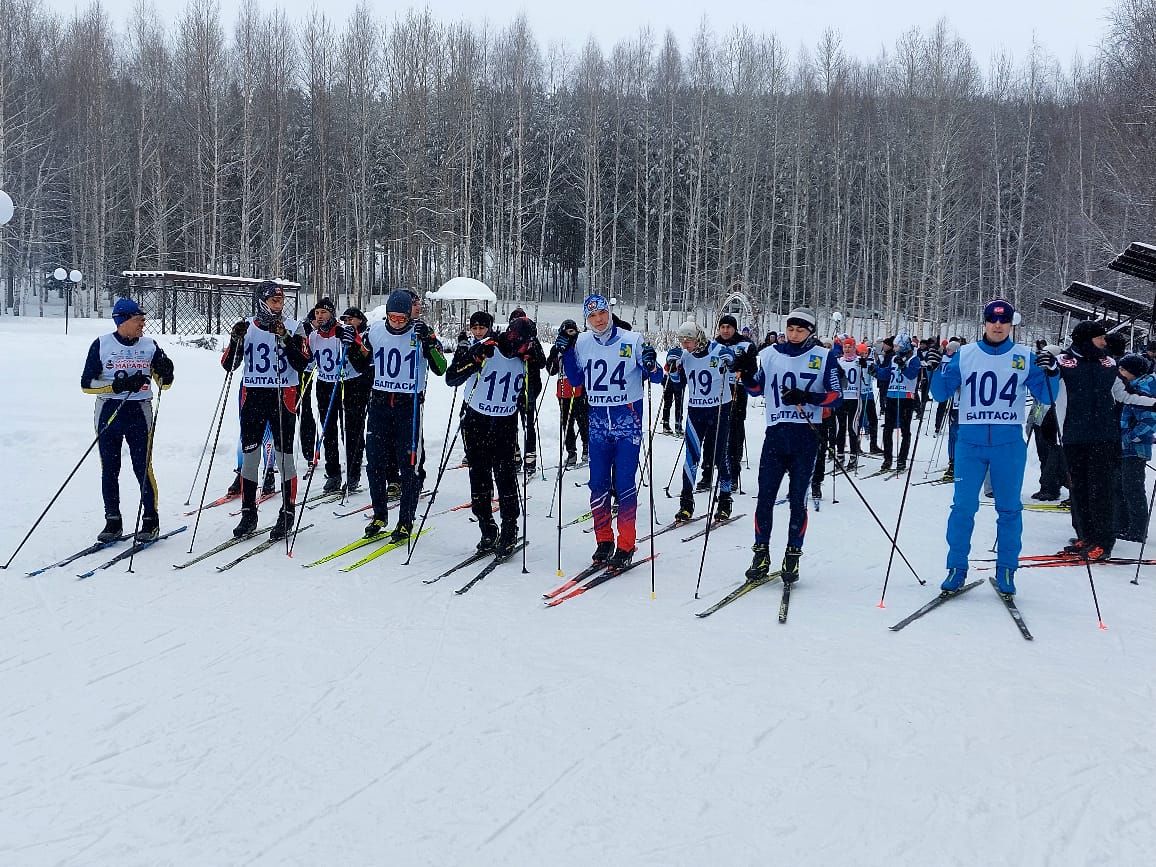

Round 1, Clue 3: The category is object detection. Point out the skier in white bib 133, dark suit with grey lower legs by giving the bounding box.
[221,280,309,539]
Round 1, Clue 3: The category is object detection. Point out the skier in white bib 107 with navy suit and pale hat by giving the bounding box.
[739,307,840,584]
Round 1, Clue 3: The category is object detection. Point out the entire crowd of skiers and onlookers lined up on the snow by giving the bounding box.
[81,281,1156,594]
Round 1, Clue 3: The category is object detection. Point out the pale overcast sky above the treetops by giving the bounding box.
[49,0,1114,68]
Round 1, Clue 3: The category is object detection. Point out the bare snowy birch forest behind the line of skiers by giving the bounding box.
[0,0,1156,332]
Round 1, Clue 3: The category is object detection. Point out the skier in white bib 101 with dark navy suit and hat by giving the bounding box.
[349,289,447,542]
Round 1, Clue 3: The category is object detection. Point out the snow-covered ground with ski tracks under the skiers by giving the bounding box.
[0,318,1156,866]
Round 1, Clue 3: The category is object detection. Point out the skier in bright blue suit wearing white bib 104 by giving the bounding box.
[927,299,1051,594]
